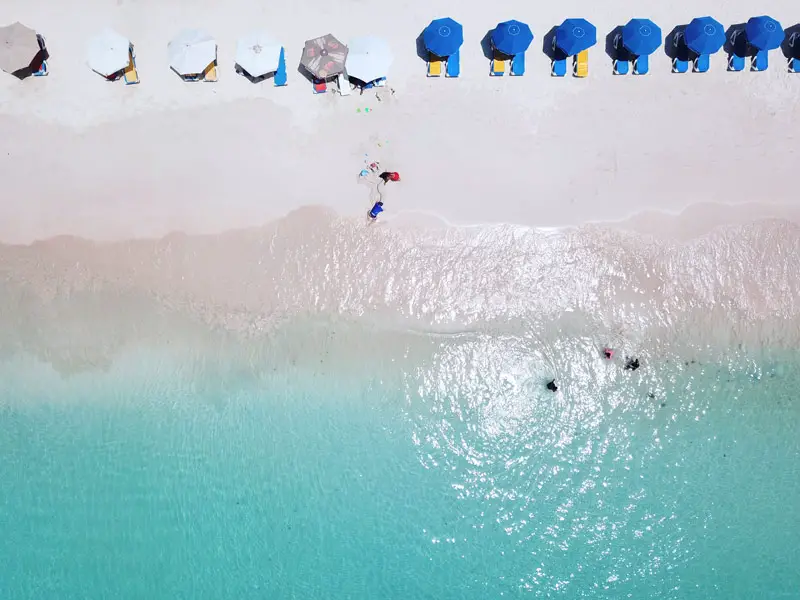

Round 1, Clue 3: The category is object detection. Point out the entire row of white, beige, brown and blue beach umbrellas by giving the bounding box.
[0,15,785,82]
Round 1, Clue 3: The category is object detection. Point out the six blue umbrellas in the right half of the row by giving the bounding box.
[422,15,785,57]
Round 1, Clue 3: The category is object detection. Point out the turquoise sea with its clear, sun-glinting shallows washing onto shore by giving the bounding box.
[0,217,800,599]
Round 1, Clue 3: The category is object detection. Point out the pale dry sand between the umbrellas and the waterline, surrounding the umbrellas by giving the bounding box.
[0,0,800,243]
